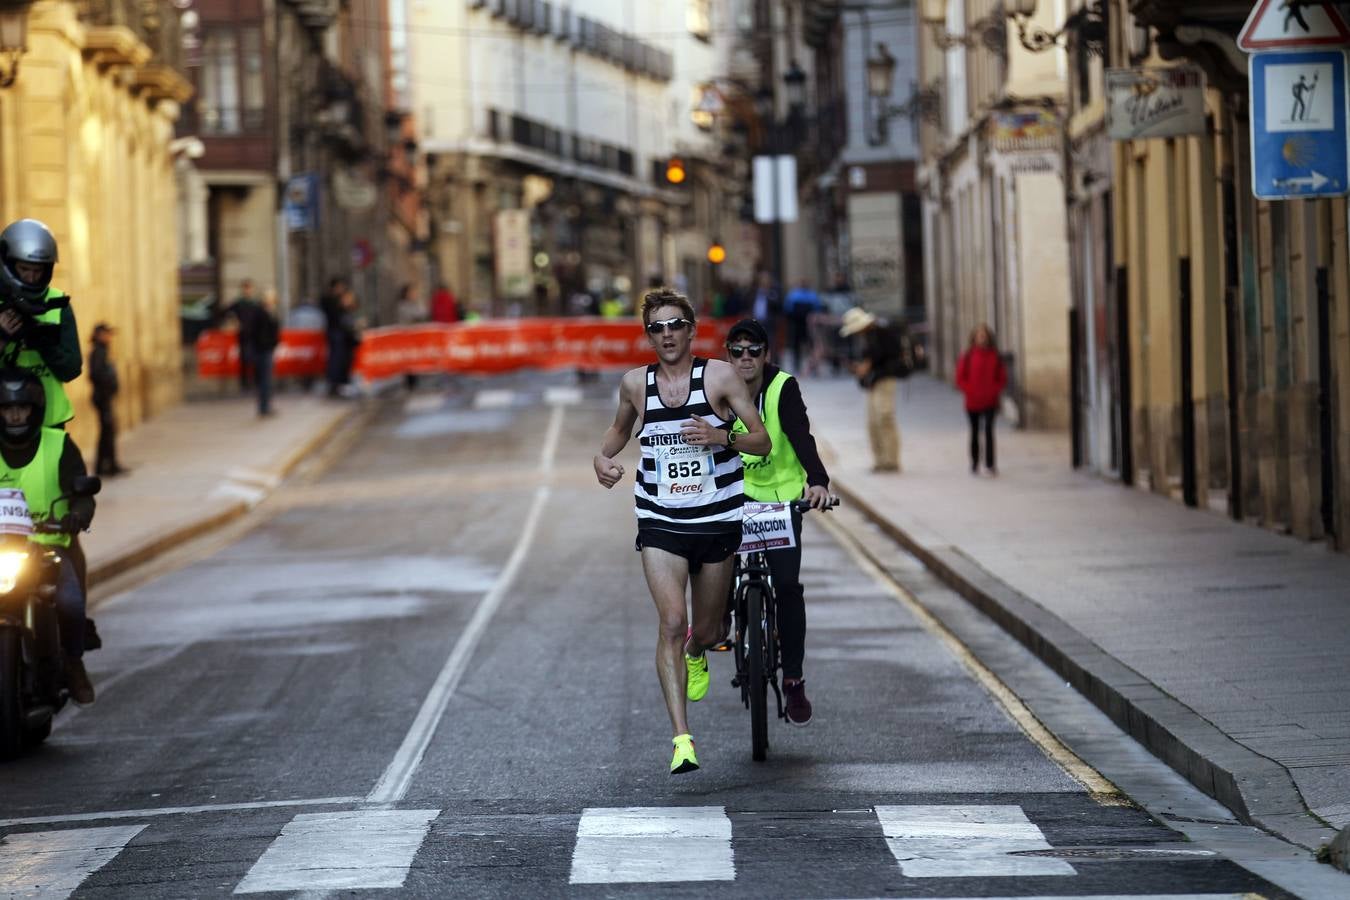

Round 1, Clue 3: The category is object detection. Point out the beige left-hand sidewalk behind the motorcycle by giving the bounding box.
[81,394,359,584]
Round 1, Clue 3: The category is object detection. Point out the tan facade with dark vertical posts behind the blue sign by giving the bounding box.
[1071,0,1350,549]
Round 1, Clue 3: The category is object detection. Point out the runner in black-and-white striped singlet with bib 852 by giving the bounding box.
[593,287,771,775]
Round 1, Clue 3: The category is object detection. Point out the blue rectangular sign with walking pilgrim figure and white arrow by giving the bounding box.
[1247,50,1350,200]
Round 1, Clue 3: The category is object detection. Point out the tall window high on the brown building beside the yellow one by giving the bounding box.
[197,26,267,135]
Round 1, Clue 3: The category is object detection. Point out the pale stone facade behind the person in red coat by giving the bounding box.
[918,0,1071,429]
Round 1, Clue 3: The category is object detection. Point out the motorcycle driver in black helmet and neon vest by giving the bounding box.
[0,368,95,704]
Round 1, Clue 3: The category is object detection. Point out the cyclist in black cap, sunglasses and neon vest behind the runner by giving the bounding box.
[726,318,830,725]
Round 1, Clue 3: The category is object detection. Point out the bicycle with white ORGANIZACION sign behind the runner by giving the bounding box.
[728,497,840,762]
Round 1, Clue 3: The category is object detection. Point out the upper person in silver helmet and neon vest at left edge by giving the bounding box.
[0,219,82,426]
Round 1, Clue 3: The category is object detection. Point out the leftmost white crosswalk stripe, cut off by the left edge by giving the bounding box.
[0,824,146,900]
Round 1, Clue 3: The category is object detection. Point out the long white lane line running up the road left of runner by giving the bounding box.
[366,406,563,804]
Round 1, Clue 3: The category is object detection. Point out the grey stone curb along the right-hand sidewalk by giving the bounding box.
[832,480,1335,850]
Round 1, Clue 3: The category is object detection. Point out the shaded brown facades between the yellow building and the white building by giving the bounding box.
[180,0,428,324]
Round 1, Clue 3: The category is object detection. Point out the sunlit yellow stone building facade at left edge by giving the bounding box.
[0,0,192,448]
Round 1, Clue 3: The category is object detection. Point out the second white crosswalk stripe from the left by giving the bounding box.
[235,810,440,893]
